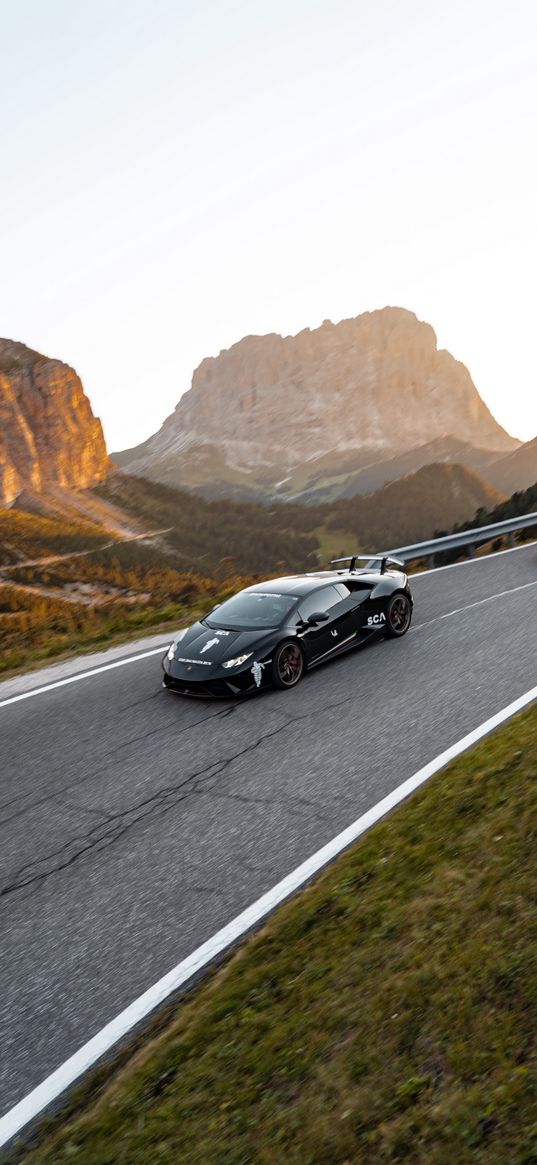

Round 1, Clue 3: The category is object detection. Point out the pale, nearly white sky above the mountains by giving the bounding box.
[0,0,537,450]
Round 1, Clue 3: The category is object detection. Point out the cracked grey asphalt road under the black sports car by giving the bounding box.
[0,544,537,1115]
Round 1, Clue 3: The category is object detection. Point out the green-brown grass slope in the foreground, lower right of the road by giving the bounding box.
[9,707,537,1165]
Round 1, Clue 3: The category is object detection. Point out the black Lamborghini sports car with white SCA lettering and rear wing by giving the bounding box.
[162,556,412,697]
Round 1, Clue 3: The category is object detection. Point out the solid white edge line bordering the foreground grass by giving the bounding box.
[0,687,537,1146]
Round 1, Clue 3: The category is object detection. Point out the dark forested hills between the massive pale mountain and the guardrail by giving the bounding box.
[97,464,501,576]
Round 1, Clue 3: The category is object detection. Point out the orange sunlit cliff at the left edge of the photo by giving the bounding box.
[0,339,109,506]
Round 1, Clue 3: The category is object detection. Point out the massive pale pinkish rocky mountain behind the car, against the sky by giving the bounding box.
[120,308,517,483]
